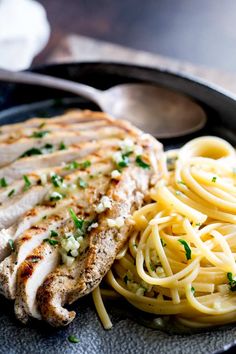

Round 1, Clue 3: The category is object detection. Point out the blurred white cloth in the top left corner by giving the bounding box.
[0,0,50,70]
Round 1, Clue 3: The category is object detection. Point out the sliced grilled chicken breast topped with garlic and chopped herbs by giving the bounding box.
[0,110,164,327]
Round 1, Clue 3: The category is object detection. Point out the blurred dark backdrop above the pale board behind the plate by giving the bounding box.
[39,0,236,72]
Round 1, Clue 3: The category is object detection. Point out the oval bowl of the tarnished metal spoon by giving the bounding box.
[99,84,206,138]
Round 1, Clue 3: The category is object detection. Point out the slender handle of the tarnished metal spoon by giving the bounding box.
[0,69,101,105]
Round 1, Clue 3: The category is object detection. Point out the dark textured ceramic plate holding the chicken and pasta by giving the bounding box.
[0,63,236,354]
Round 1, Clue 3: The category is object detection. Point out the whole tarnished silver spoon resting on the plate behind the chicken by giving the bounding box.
[0,69,206,138]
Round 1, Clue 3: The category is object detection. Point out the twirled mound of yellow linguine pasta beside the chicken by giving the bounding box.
[95,137,236,328]
